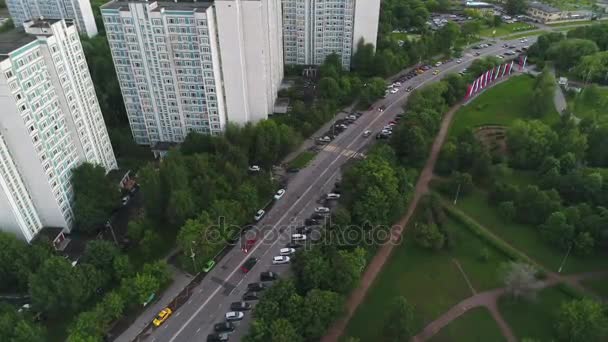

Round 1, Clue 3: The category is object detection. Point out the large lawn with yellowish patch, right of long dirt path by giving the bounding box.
[345,221,506,341]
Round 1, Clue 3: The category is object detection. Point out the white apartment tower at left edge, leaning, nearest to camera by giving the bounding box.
[0,20,116,241]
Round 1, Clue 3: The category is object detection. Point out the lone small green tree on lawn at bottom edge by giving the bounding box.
[384,296,415,342]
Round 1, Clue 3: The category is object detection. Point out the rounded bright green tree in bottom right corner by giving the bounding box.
[556,298,608,342]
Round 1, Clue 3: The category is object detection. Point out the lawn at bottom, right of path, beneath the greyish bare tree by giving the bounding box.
[498,287,571,342]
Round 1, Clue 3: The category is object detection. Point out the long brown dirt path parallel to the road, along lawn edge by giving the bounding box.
[321,105,461,342]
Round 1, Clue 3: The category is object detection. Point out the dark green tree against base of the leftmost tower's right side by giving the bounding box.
[71,163,120,233]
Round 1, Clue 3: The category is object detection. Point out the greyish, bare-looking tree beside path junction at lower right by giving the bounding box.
[502,261,539,299]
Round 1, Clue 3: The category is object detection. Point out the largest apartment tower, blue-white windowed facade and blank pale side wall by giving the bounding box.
[101,0,283,145]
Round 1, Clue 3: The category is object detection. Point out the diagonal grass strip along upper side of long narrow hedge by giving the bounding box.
[457,189,608,273]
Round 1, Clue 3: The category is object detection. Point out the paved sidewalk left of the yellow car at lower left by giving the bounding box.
[114,264,193,342]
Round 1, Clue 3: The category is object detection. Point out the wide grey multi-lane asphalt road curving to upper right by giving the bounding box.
[134,37,535,342]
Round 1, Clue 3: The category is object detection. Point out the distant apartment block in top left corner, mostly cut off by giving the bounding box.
[6,0,97,37]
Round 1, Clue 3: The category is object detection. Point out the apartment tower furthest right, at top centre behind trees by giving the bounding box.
[281,0,380,69]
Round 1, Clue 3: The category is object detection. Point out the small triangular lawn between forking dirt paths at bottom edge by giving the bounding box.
[430,307,506,342]
